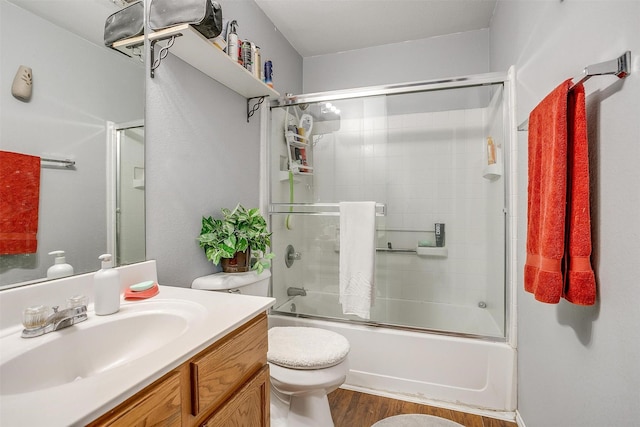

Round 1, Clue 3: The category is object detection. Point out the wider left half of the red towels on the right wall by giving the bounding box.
[524,80,571,304]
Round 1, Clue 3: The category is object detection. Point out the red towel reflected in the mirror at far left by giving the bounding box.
[0,151,40,255]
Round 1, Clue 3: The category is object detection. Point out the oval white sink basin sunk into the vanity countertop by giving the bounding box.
[0,302,203,396]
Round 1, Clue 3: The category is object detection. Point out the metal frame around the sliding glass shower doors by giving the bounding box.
[260,67,517,348]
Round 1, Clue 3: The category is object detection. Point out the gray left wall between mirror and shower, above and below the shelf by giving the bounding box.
[145,1,302,287]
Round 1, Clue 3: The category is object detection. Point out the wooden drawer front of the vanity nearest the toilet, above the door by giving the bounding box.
[190,314,268,416]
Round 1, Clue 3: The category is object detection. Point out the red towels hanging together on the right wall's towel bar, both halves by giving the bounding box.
[524,80,596,305]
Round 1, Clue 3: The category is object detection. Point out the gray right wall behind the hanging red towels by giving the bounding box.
[491,0,640,427]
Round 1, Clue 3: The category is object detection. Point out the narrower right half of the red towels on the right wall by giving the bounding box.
[564,84,596,305]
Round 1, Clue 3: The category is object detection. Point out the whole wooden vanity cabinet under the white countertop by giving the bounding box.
[89,313,269,427]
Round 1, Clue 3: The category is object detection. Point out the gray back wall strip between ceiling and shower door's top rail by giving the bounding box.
[304,29,490,93]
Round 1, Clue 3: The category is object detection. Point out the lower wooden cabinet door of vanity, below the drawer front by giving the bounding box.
[202,366,269,427]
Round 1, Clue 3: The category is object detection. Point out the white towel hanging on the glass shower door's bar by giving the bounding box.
[340,202,376,319]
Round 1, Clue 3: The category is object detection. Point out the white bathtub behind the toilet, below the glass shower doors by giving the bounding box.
[269,293,516,419]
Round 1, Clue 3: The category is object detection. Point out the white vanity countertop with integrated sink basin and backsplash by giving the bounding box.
[0,270,275,426]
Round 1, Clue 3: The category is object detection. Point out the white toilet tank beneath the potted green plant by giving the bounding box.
[191,270,271,297]
